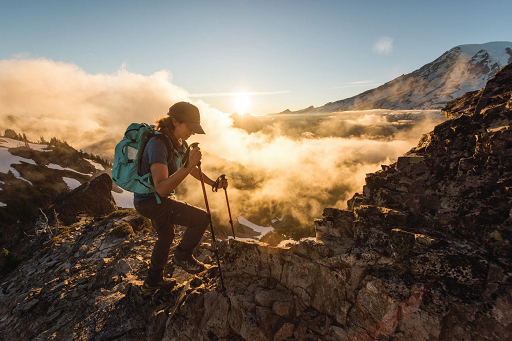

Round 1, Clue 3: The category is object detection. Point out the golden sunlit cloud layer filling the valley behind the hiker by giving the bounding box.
[0,59,440,236]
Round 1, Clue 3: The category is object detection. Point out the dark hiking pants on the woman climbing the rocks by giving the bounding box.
[134,198,210,285]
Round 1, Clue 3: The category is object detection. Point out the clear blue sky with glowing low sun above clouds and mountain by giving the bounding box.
[0,0,512,114]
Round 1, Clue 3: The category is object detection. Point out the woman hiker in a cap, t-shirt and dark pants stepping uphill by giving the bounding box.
[134,102,228,292]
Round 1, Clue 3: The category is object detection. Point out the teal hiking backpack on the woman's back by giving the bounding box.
[112,123,176,203]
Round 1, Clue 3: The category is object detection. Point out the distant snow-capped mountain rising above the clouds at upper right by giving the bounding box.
[292,42,512,113]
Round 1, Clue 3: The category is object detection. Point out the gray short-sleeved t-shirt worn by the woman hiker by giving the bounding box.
[133,137,187,201]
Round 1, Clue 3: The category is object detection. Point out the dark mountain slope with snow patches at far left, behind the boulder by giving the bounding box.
[0,136,113,245]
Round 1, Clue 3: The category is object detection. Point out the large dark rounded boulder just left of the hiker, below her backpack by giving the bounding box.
[55,173,117,225]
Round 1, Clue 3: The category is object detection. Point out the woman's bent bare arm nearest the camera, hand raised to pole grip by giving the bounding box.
[150,148,201,197]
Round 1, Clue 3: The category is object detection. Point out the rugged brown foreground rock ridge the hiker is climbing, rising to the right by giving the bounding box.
[0,66,512,341]
